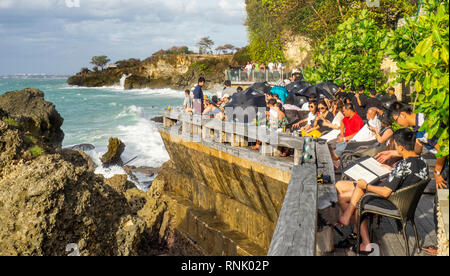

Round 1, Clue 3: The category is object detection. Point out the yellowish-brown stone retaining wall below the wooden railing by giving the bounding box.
[155,131,291,256]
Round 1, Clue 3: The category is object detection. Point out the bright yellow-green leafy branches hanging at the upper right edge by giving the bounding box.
[388,0,449,157]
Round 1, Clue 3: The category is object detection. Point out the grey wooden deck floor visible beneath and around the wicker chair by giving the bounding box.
[330,194,437,256]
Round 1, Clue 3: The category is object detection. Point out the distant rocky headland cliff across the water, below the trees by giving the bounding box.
[67,55,233,90]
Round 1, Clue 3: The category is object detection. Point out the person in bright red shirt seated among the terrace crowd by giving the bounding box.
[330,104,364,160]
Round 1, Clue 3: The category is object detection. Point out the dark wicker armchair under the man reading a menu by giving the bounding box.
[356,179,431,256]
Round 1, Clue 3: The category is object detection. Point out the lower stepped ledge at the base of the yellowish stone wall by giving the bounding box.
[169,194,267,256]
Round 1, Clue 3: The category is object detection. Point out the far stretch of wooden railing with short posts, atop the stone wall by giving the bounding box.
[163,110,304,165]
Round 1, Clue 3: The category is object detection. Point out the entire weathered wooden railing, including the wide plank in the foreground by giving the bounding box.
[163,110,337,256]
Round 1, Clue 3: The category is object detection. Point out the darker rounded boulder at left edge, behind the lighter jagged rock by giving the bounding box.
[0,88,64,147]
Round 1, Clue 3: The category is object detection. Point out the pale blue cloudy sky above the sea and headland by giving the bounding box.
[0,0,248,75]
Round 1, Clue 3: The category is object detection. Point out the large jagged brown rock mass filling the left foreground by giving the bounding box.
[0,89,199,256]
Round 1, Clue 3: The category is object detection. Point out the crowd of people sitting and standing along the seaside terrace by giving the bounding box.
[184,74,449,254]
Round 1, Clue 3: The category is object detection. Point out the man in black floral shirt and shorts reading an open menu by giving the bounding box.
[336,128,429,255]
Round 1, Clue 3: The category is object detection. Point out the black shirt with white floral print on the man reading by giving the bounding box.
[383,157,429,192]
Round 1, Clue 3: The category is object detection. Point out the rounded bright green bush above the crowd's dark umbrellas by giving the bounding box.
[305,10,386,91]
